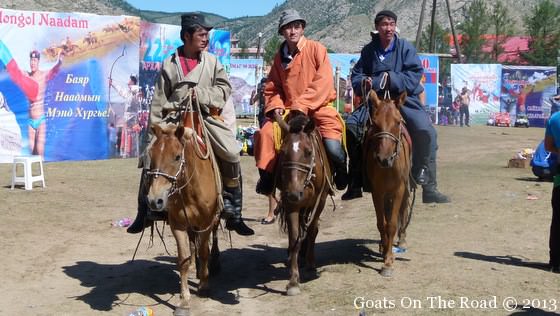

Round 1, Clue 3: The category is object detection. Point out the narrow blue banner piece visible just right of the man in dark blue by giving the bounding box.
[418,54,439,124]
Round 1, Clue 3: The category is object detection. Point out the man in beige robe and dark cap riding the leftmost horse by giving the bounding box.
[127,13,254,235]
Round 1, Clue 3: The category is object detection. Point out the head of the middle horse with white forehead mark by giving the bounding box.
[279,115,316,204]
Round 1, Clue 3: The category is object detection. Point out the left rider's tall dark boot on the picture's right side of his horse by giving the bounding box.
[220,162,255,236]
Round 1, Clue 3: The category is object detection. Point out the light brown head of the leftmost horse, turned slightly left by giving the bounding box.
[147,125,193,212]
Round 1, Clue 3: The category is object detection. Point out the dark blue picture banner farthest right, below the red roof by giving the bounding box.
[500,66,556,127]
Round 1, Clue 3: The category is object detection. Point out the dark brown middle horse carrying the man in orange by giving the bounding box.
[276,115,332,296]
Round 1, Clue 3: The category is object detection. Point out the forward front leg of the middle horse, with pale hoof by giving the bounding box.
[286,211,301,296]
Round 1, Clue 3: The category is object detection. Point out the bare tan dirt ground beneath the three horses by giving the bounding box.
[0,126,560,316]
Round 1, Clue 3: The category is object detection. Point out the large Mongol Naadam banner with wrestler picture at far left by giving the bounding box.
[0,9,140,162]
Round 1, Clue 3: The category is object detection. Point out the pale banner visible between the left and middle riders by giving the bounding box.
[229,59,263,117]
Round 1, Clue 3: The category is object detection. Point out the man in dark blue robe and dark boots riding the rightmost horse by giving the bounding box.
[342,10,450,203]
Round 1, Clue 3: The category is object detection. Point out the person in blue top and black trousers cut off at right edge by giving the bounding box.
[544,112,560,273]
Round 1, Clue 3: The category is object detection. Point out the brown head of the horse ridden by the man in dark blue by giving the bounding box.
[369,90,406,168]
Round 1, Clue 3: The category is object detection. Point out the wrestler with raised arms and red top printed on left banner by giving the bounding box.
[0,40,63,156]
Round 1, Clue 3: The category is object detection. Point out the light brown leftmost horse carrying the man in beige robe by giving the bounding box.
[147,125,219,315]
